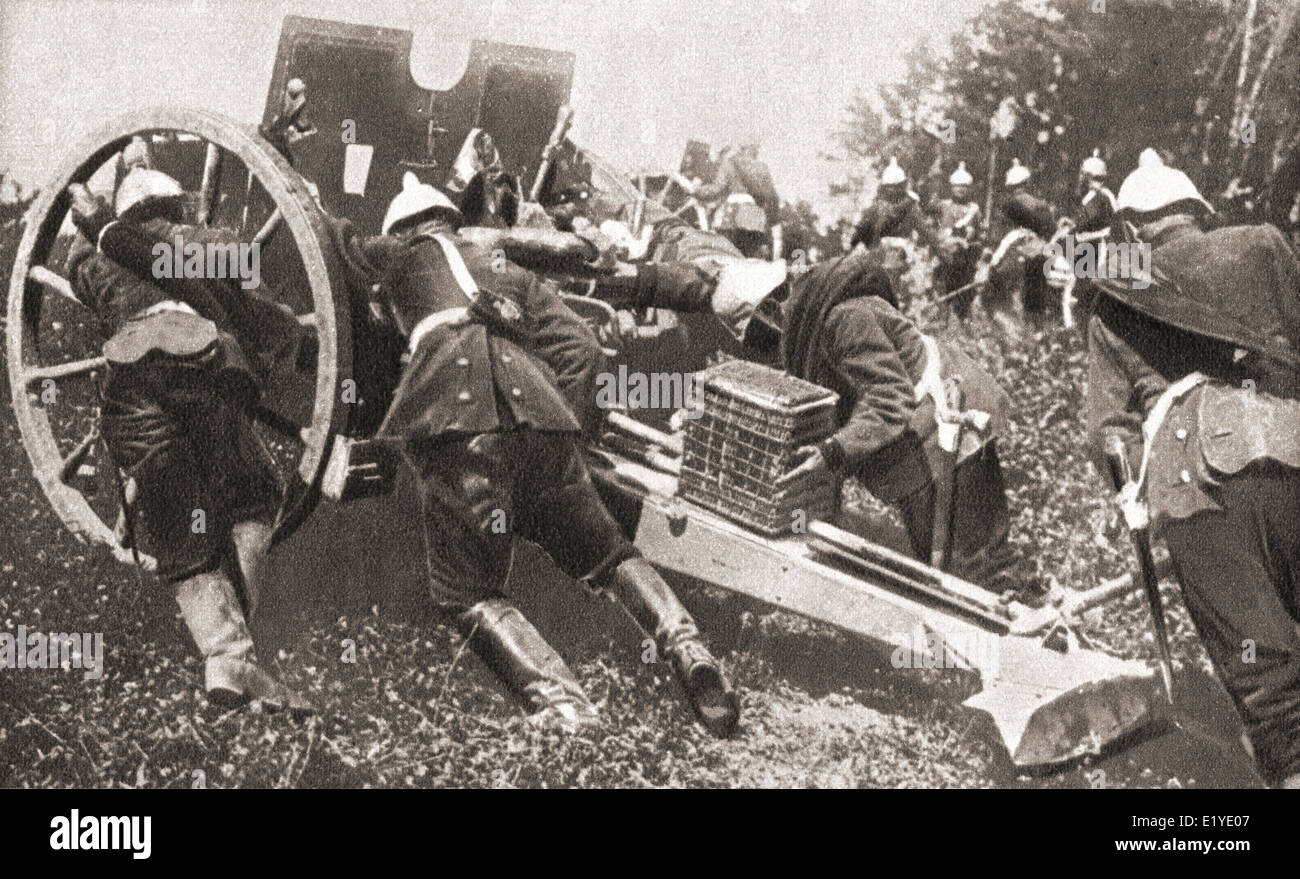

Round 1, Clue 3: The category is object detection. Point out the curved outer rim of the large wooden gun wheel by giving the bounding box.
[5,107,351,569]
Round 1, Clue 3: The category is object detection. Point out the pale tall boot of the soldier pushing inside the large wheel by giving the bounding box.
[176,571,313,714]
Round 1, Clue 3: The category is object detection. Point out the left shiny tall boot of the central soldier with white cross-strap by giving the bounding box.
[456,598,601,732]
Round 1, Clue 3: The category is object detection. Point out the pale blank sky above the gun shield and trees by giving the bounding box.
[0,0,985,218]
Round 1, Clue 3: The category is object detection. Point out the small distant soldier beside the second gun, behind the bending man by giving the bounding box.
[690,137,781,259]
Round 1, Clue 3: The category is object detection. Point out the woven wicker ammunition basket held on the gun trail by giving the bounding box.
[677,360,839,537]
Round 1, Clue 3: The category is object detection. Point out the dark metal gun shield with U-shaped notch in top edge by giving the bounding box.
[263,16,575,233]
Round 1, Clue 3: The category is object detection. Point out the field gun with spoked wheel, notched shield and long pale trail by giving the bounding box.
[7,17,1160,766]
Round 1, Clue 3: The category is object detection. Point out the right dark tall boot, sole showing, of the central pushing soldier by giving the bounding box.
[608,558,740,739]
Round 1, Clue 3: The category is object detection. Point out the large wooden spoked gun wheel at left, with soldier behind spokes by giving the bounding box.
[5,108,351,564]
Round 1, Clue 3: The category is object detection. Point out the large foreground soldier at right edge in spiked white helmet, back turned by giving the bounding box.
[1086,150,1300,787]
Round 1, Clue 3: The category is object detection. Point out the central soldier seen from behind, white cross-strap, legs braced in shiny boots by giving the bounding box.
[321,174,740,735]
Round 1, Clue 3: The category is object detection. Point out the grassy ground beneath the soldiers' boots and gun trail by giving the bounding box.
[0,236,1249,787]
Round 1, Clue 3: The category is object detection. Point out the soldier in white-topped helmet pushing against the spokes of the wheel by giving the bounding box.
[69,168,311,711]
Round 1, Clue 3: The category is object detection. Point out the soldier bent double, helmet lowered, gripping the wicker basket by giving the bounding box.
[597,251,1030,598]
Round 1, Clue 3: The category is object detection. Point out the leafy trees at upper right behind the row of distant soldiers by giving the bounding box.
[837,0,1300,235]
